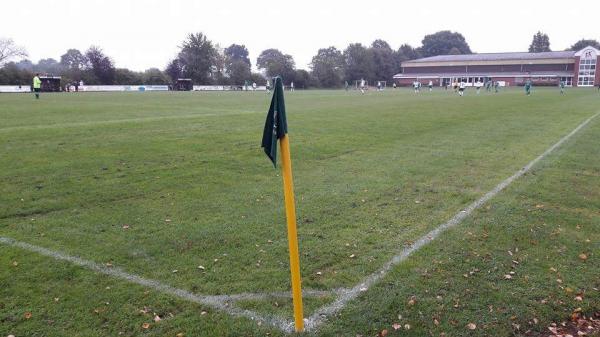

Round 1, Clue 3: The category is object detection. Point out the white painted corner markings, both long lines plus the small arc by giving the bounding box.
[0,112,600,333]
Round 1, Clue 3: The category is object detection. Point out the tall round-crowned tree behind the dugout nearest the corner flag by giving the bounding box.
[177,33,217,84]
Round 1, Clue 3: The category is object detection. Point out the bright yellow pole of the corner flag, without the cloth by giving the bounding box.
[279,135,304,332]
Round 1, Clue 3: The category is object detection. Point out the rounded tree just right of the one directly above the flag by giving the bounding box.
[310,47,344,88]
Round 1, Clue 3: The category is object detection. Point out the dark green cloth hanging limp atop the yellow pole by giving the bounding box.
[262,76,287,166]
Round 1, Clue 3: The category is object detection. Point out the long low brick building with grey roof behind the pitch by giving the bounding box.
[394,47,600,87]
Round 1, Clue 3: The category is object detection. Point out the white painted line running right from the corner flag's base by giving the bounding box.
[305,112,600,330]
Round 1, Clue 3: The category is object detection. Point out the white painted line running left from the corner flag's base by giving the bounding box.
[0,236,294,332]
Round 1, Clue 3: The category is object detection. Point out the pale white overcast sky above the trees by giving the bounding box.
[0,0,600,70]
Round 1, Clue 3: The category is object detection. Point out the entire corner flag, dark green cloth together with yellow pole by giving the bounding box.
[262,76,304,332]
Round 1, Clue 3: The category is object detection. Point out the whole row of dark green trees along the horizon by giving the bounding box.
[0,31,600,88]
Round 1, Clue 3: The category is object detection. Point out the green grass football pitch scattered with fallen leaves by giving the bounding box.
[0,88,600,337]
